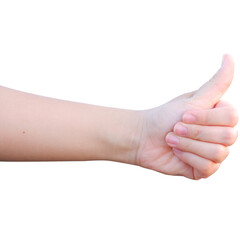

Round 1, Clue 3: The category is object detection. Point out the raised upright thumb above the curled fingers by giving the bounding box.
[193,54,234,108]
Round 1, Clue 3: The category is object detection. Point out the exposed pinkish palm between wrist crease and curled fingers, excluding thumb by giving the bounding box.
[137,93,202,178]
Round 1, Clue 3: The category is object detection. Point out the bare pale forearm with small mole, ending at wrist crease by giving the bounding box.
[0,87,141,164]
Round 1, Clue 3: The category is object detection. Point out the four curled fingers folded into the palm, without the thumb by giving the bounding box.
[166,101,238,179]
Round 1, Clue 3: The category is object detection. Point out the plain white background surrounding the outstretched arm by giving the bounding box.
[0,0,240,240]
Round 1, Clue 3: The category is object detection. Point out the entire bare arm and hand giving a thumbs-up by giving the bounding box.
[0,55,238,180]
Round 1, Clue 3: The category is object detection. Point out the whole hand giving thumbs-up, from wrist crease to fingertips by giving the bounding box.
[136,55,238,179]
